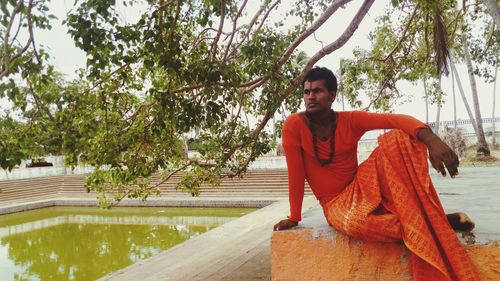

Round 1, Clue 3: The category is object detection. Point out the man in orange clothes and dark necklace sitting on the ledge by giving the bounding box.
[274,67,478,281]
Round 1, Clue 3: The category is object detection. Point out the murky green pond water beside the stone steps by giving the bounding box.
[0,207,255,281]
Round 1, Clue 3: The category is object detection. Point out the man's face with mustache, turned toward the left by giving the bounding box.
[304,80,335,113]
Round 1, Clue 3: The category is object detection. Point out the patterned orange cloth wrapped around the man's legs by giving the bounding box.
[323,130,479,281]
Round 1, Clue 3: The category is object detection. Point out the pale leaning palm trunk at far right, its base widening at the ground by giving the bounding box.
[462,33,490,156]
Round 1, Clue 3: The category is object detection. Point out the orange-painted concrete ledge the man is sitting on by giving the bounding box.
[271,207,500,281]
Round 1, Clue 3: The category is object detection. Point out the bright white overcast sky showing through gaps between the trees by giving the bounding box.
[0,0,500,121]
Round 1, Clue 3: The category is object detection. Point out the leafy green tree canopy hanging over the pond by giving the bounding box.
[0,0,373,205]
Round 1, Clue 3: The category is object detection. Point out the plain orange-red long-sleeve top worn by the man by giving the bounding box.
[282,111,429,222]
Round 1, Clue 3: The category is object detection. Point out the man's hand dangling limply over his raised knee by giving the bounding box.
[417,129,460,177]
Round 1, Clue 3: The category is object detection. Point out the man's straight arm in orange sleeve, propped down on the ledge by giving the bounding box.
[273,116,305,230]
